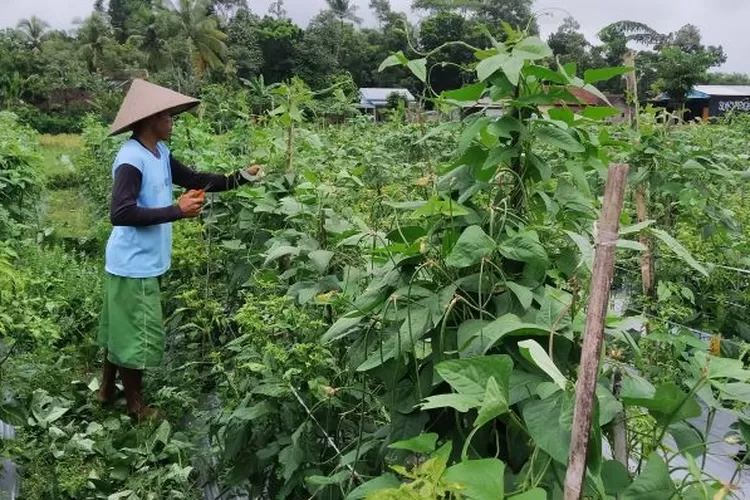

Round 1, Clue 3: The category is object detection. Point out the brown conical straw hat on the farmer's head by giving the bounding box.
[109,78,200,135]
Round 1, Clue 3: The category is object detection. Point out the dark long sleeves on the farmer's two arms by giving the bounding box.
[110,155,247,226]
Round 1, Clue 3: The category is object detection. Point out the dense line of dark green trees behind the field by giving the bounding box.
[0,0,750,132]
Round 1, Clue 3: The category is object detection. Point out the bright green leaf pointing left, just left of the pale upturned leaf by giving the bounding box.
[435,354,513,400]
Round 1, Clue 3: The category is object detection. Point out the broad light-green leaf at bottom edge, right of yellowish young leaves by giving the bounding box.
[445,458,505,500]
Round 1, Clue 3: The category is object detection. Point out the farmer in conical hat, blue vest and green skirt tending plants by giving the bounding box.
[97,80,260,420]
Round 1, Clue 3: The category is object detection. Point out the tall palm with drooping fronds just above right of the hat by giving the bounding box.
[162,0,227,76]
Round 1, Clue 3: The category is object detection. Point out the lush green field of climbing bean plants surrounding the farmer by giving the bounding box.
[0,32,750,500]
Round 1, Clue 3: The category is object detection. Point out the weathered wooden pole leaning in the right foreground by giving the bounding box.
[565,164,628,500]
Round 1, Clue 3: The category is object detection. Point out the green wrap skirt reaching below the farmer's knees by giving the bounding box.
[98,273,165,370]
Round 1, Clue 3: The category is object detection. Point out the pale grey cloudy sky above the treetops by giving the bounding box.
[0,0,750,73]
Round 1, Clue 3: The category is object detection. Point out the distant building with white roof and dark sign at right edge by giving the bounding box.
[651,85,750,120]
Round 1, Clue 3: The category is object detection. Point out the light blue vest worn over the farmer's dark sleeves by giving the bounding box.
[105,139,174,278]
